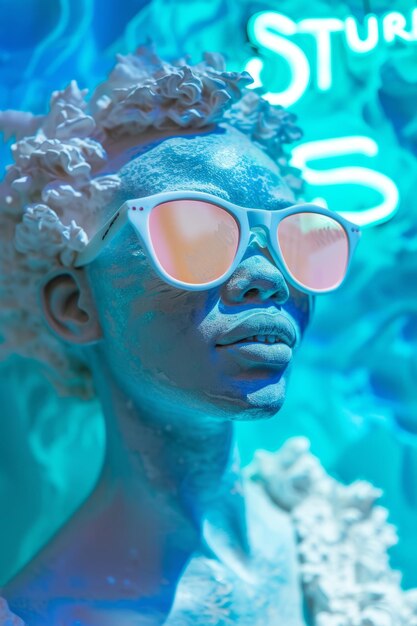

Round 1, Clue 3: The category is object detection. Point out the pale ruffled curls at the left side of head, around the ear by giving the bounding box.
[0,83,119,395]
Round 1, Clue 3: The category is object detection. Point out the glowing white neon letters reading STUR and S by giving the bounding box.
[245,9,404,226]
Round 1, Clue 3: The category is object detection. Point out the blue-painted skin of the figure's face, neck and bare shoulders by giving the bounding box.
[3,130,309,626]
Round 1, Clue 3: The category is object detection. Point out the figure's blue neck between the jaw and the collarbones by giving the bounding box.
[97,368,244,531]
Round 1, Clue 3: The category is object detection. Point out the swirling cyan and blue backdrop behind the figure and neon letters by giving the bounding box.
[0,0,417,587]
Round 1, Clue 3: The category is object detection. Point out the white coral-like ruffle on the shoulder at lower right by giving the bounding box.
[247,438,417,626]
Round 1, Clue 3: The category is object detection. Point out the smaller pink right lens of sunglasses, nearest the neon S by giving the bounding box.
[278,213,349,292]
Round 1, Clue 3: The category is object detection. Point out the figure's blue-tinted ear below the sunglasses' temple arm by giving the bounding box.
[41,268,102,345]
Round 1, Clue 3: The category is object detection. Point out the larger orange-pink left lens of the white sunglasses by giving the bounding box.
[149,200,239,285]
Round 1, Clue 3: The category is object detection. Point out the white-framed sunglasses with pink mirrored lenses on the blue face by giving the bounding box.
[75,191,360,294]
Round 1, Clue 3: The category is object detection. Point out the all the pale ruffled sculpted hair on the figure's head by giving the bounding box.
[0,47,301,395]
